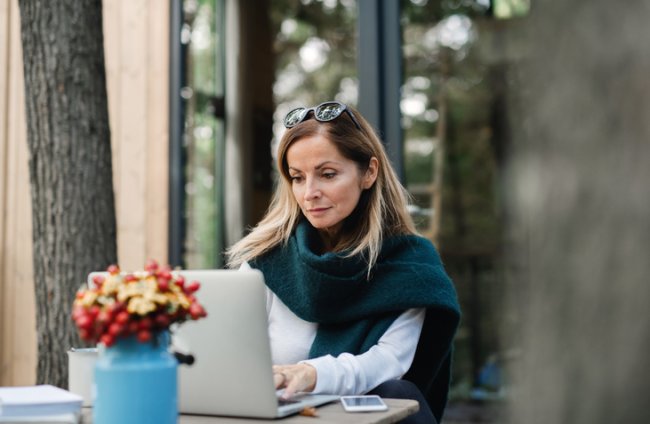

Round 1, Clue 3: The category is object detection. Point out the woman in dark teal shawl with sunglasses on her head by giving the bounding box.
[227,102,460,422]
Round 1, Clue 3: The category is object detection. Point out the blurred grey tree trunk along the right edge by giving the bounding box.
[508,0,650,424]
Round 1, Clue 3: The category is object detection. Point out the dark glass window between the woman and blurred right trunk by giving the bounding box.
[400,0,529,404]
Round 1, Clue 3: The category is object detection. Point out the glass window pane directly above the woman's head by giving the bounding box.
[271,0,358,154]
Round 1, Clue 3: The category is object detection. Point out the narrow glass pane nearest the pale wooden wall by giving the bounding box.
[181,0,224,268]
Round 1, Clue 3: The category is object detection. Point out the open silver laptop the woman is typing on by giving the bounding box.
[172,270,339,418]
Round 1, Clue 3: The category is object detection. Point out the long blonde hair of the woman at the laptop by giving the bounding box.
[226,107,417,274]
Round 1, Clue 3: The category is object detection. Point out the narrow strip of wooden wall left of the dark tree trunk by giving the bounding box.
[0,0,36,385]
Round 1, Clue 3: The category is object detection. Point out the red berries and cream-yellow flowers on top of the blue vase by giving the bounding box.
[72,260,207,347]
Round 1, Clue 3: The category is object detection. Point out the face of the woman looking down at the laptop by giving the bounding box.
[286,135,378,245]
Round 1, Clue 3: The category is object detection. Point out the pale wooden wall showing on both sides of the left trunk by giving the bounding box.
[0,0,169,385]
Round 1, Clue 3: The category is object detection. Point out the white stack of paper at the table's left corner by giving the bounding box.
[0,385,83,423]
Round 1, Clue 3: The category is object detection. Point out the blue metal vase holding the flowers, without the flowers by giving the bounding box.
[93,331,178,424]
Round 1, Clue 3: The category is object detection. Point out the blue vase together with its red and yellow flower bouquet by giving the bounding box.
[72,261,207,424]
